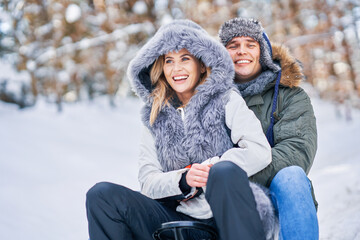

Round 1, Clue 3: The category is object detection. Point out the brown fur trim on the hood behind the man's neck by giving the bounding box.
[271,43,305,88]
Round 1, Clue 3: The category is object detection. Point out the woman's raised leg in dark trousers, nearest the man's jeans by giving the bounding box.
[205,161,265,240]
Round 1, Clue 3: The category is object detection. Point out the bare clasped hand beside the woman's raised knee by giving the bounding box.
[186,163,212,187]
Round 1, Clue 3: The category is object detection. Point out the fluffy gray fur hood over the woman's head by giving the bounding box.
[127,20,234,105]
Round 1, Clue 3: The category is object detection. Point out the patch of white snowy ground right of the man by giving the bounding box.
[310,99,360,240]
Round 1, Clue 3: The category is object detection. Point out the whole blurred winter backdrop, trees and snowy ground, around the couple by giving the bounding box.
[0,0,360,240]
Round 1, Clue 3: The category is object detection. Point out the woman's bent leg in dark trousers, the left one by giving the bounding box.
[86,182,187,240]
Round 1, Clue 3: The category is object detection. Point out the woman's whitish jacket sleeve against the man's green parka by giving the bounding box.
[213,90,271,176]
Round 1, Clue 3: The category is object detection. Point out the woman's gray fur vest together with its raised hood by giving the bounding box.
[128,20,235,171]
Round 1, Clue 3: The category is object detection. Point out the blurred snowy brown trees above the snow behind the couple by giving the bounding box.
[0,0,360,110]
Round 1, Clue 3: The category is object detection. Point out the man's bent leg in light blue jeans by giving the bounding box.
[270,166,319,240]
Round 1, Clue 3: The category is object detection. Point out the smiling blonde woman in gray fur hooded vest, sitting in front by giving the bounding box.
[87,20,273,240]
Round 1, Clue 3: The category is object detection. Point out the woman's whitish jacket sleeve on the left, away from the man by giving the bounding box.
[138,127,187,199]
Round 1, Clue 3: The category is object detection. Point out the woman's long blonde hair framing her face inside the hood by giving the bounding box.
[150,55,211,125]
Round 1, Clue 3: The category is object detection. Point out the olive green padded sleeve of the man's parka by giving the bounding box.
[251,87,317,187]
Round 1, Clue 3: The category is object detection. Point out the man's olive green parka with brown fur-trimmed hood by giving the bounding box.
[248,44,317,205]
